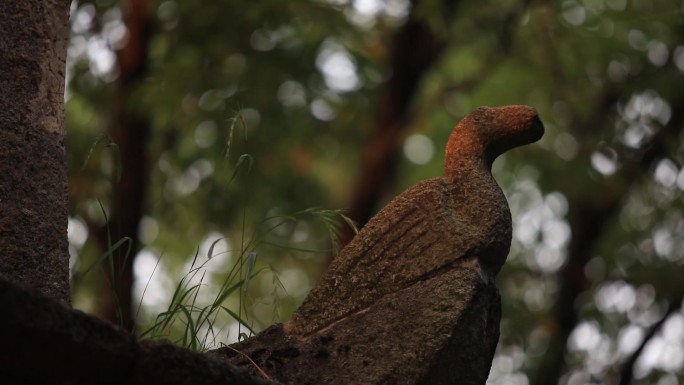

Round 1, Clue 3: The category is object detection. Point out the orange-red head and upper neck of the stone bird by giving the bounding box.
[444,106,544,179]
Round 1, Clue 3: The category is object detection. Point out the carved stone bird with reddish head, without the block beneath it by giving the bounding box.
[285,106,544,334]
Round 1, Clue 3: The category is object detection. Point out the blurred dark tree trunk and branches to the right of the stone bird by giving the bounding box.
[530,89,684,385]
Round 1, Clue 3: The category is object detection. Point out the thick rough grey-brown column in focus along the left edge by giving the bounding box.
[0,0,70,303]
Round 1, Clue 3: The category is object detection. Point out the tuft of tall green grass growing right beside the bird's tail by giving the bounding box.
[134,111,356,351]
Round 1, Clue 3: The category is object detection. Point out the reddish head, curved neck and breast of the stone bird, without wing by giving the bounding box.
[444,106,544,277]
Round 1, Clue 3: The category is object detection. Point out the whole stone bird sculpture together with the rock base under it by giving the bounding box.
[219,106,544,384]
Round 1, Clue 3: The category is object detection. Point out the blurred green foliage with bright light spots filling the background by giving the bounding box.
[67,0,684,385]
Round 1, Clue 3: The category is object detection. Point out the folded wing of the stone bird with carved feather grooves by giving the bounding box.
[287,178,476,334]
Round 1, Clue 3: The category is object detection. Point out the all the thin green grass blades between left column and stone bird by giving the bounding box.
[74,110,356,351]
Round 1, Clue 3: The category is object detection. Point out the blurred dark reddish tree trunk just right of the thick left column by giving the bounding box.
[93,0,149,330]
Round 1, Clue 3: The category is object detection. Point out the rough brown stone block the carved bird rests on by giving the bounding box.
[212,263,500,385]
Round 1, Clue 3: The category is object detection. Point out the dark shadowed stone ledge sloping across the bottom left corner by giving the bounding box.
[0,278,276,385]
